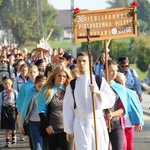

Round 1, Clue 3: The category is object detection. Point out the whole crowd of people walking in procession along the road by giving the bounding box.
[0,41,144,150]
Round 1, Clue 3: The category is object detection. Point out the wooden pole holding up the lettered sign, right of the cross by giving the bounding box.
[104,40,111,132]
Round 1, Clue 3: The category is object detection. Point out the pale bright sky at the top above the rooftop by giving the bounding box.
[48,0,108,10]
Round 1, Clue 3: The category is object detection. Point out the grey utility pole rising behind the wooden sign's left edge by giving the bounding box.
[70,0,77,58]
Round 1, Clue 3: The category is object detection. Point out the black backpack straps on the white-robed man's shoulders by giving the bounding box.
[70,75,102,109]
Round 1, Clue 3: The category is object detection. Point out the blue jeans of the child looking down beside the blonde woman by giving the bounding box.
[29,121,48,150]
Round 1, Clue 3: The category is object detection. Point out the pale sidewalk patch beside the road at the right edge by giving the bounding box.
[141,93,150,116]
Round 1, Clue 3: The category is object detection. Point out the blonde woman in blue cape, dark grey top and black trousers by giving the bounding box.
[36,65,71,150]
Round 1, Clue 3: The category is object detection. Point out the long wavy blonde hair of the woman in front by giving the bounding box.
[43,64,72,103]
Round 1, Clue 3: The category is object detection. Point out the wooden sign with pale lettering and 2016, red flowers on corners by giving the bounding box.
[73,7,138,42]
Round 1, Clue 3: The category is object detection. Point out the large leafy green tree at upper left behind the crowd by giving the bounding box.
[0,0,60,45]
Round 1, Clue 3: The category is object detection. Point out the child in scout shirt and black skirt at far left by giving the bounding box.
[0,77,18,147]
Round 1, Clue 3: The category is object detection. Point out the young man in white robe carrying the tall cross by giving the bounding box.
[63,52,115,150]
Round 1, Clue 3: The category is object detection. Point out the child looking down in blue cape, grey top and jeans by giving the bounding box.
[19,75,46,150]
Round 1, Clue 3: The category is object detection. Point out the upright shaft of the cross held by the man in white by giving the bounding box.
[87,28,98,150]
